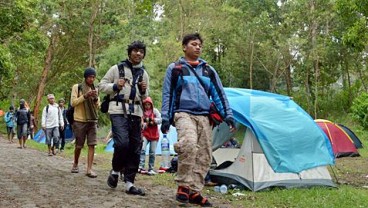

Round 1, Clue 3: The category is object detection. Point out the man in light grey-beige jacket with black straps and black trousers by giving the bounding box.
[99,41,149,195]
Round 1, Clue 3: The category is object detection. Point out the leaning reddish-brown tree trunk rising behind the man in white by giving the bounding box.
[33,35,56,127]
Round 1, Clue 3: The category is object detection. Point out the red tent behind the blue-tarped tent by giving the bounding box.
[315,119,359,157]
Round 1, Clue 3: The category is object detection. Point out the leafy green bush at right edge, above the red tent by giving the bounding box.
[351,93,368,128]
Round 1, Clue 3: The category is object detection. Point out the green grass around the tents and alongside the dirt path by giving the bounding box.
[0,116,368,207]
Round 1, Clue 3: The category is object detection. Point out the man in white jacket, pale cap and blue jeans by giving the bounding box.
[41,94,64,156]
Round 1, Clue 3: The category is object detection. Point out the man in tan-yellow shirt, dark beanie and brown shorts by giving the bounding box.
[70,67,100,178]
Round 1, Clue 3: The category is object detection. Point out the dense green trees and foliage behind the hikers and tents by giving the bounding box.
[0,0,368,127]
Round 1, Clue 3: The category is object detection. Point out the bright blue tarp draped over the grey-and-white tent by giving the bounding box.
[225,88,335,173]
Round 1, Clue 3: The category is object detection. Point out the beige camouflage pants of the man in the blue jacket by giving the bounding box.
[174,112,212,192]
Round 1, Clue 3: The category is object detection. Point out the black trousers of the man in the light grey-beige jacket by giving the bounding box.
[110,114,142,183]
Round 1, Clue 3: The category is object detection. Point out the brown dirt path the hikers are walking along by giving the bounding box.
[0,137,229,208]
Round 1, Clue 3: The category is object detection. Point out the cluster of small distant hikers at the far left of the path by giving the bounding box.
[4,99,36,149]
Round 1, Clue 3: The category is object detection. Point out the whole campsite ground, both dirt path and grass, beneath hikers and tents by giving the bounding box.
[0,133,368,207]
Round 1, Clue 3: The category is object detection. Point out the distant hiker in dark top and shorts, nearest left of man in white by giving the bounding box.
[16,99,31,149]
